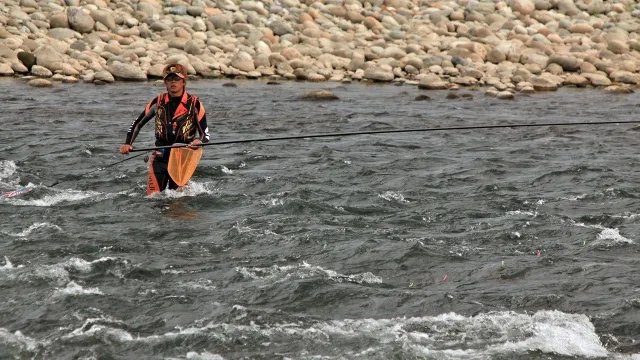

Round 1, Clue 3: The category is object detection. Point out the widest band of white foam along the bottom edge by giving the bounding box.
[55,311,610,359]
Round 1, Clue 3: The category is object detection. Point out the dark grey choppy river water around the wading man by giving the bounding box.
[0,79,640,360]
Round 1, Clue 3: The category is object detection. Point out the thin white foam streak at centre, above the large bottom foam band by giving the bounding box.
[235,262,382,284]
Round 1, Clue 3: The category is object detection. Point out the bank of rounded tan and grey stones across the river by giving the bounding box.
[0,0,640,98]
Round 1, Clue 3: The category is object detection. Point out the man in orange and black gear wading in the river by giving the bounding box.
[120,64,209,195]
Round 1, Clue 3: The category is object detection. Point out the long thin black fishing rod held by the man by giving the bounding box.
[131,120,640,152]
